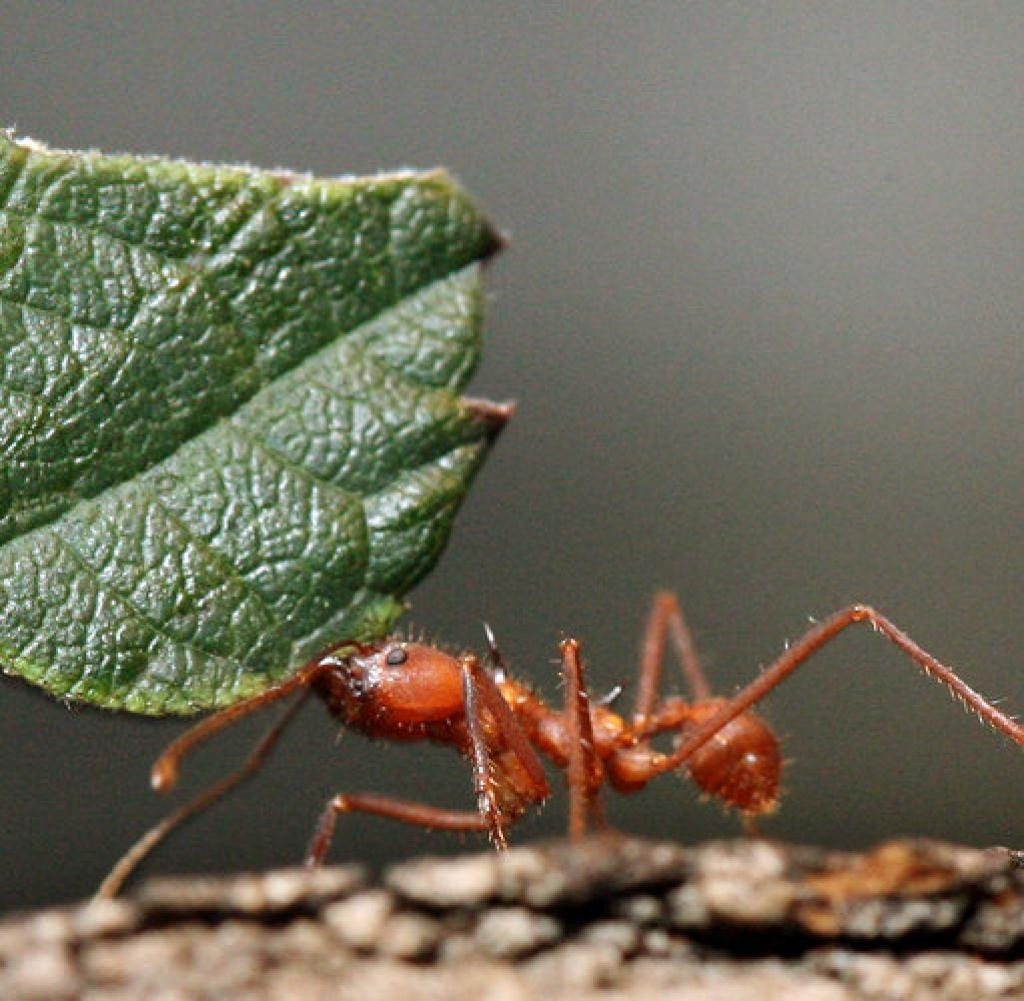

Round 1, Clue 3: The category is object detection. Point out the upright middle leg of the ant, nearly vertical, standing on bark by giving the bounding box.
[560,639,605,840]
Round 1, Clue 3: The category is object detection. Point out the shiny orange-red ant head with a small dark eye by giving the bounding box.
[335,639,463,727]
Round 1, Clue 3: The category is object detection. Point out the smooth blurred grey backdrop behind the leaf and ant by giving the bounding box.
[0,0,1024,909]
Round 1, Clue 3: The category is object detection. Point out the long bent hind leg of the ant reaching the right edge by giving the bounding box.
[655,605,1024,774]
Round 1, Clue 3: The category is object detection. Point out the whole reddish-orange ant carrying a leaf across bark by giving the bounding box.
[97,592,1024,897]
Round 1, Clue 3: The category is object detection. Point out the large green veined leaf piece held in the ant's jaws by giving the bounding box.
[0,133,505,714]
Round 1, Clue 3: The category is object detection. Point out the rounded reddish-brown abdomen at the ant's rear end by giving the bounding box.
[684,699,782,814]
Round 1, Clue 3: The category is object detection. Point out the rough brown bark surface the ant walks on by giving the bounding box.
[0,838,1024,1001]
